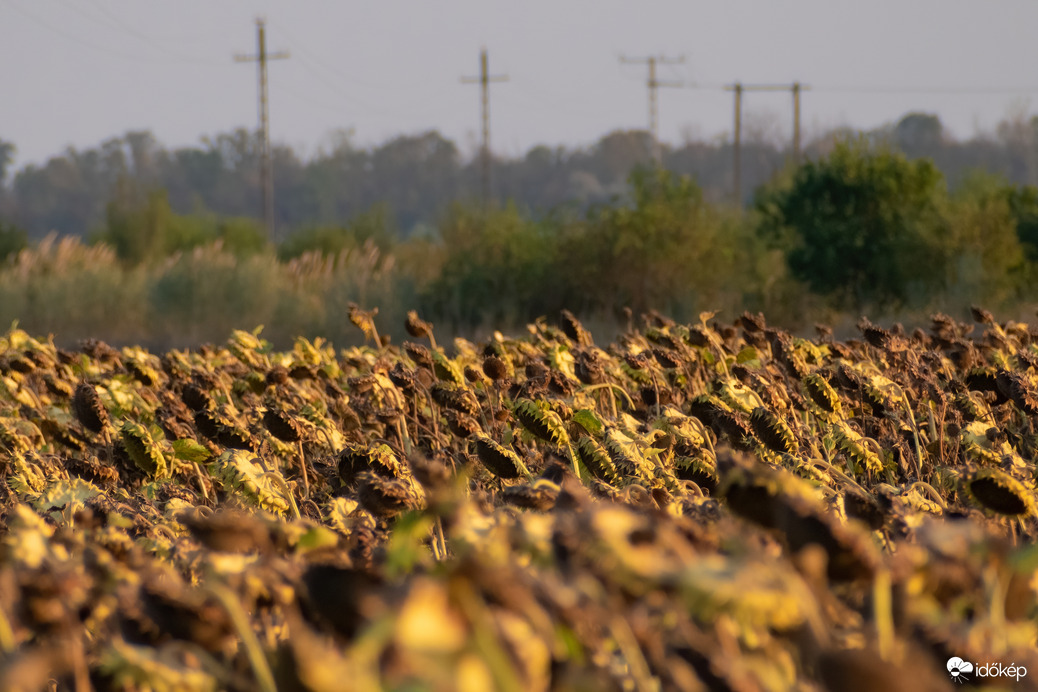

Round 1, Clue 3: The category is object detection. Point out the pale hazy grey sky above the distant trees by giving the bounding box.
[0,0,1038,167]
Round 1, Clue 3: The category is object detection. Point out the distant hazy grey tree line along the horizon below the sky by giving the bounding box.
[0,113,1038,242]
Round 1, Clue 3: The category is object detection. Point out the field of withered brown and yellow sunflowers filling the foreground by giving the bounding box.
[0,306,1038,692]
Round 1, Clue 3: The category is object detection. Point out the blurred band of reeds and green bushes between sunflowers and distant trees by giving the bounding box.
[0,130,1038,349]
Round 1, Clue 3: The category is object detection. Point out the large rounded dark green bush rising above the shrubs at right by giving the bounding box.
[756,139,948,310]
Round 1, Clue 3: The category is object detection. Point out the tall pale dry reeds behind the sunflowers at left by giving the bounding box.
[0,236,413,348]
